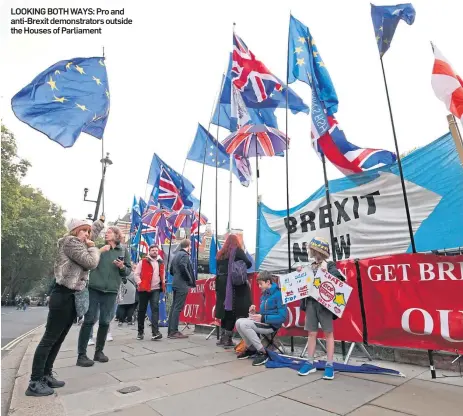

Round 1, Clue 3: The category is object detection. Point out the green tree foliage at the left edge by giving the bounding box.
[1,125,66,298]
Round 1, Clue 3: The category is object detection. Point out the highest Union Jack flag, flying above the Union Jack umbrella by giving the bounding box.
[231,33,282,103]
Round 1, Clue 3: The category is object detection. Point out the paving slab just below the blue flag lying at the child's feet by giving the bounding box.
[282,375,394,415]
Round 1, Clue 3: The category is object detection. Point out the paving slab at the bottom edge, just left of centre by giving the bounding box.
[148,384,262,416]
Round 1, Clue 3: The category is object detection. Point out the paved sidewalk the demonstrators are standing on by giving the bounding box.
[10,325,463,416]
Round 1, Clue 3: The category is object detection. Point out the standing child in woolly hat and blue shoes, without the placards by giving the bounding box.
[298,237,345,380]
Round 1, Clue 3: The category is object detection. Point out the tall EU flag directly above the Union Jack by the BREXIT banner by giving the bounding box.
[288,16,338,115]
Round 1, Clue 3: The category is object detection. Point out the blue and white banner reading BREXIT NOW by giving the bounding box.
[256,133,463,272]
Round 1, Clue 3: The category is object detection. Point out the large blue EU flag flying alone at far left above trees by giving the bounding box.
[11,57,109,147]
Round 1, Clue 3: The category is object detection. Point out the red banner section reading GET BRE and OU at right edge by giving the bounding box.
[362,254,463,352]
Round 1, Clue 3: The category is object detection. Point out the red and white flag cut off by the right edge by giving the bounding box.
[431,45,463,123]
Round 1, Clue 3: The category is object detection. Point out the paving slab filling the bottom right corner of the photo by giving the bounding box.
[372,380,463,416]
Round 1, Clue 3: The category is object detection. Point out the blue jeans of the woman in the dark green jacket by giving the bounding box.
[77,289,117,355]
